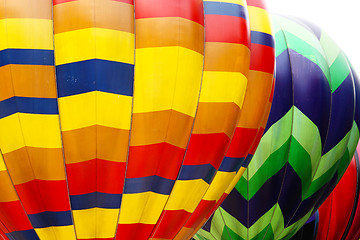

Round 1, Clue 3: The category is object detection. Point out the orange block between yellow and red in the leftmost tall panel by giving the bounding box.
[4,147,65,184]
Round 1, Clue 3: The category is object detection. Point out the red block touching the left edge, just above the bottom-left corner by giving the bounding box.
[0,201,32,232]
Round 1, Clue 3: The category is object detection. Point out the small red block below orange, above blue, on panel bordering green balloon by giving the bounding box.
[226,127,258,158]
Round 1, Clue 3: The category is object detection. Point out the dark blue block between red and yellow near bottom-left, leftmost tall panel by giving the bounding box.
[28,211,72,228]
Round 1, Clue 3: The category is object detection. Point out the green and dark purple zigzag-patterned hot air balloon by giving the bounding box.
[194,15,360,239]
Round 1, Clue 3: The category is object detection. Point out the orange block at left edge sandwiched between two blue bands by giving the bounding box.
[0,65,57,101]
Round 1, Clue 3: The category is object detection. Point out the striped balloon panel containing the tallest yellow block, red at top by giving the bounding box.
[116,0,207,239]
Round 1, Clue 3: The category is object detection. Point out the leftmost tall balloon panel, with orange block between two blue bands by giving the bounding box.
[0,0,75,239]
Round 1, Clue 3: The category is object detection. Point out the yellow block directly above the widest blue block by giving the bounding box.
[55,28,134,65]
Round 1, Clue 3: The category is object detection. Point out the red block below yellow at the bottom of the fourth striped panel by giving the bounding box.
[150,210,191,239]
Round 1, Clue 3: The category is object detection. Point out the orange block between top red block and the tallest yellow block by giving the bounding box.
[136,17,204,54]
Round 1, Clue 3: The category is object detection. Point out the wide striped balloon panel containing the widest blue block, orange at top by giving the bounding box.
[53,0,135,239]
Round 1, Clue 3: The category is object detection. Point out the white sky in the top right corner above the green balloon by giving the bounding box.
[266,0,360,74]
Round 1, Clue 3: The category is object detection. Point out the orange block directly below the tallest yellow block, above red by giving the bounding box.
[130,110,193,148]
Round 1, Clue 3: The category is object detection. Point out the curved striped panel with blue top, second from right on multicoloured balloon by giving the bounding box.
[151,1,250,239]
